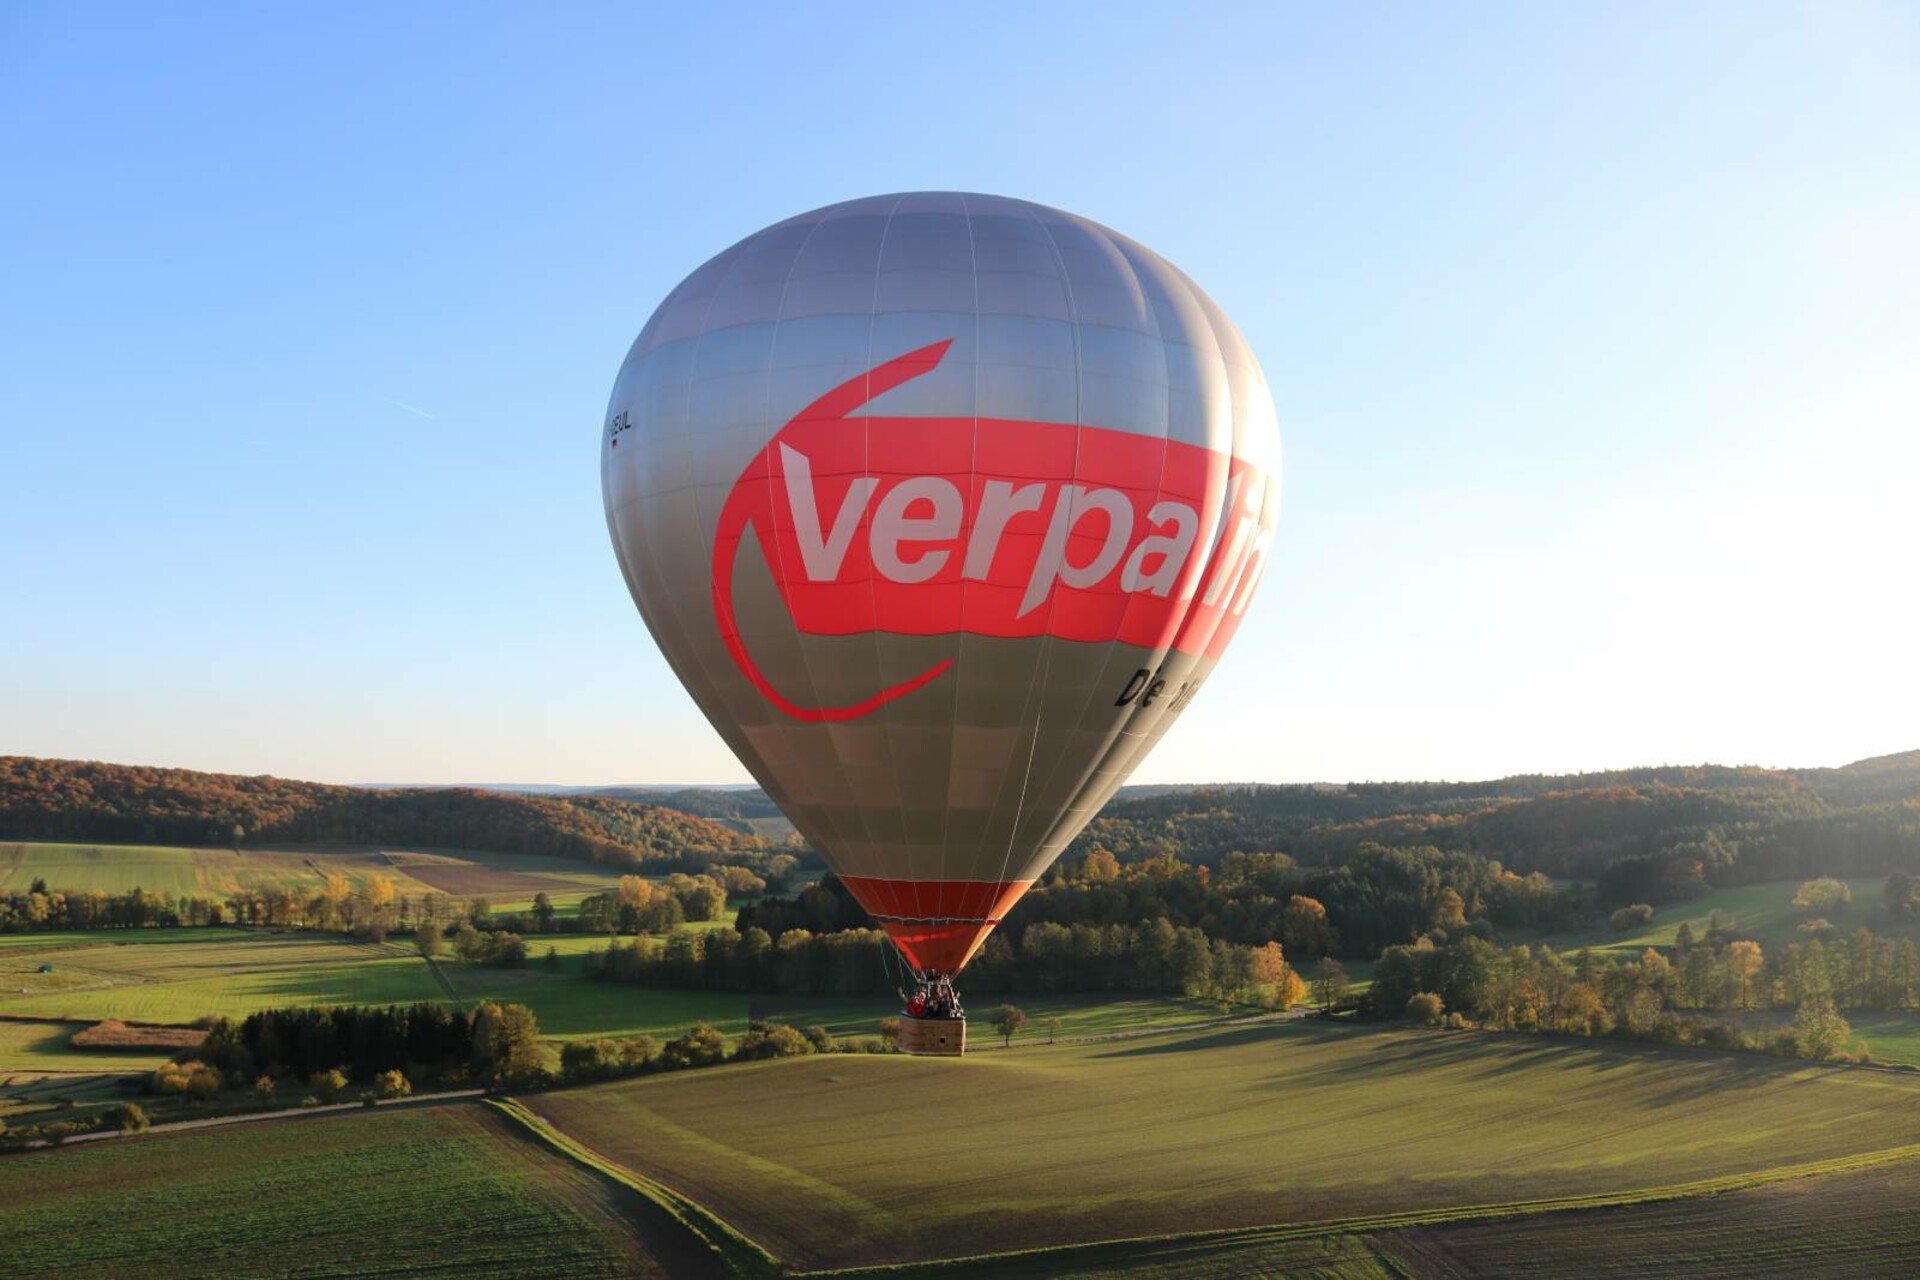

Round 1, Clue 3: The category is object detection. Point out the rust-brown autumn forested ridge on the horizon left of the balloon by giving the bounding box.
[0,756,760,869]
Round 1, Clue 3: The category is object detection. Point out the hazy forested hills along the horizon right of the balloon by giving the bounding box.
[1073,752,1920,883]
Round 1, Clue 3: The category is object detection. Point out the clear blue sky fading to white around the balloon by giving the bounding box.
[0,2,1920,783]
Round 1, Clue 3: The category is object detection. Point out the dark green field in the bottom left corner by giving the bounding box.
[0,1107,701,1280]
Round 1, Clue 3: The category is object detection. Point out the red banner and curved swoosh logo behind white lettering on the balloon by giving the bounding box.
[712,342,1273,722]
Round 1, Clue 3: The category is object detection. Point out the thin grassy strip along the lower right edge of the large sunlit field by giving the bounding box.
[789,1142,1920,1280]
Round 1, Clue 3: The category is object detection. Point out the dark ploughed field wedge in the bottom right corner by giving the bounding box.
[1375,1161,1920,1280]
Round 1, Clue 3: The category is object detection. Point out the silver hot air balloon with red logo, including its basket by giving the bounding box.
[601,192,1281,1052]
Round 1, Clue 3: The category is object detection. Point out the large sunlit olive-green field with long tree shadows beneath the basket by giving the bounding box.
[526,1023,1920,1267]
